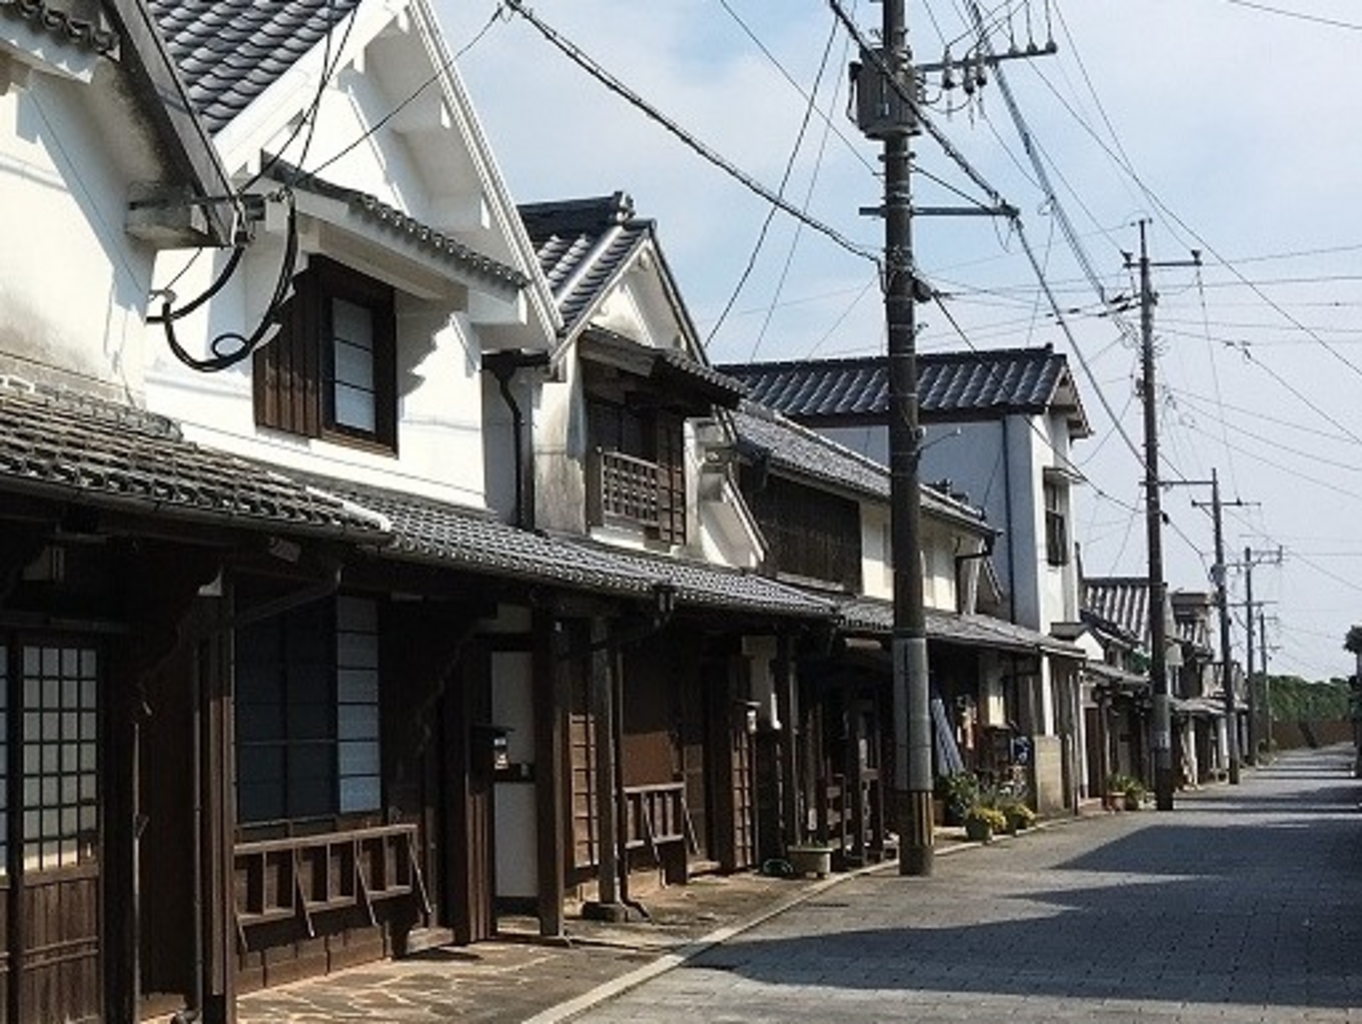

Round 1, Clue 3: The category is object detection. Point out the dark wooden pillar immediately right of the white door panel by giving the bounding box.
[533,611,569,937]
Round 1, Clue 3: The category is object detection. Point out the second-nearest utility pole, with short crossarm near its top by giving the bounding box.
[1125,221,1201,810]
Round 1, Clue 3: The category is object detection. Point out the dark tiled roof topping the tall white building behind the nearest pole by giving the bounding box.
[718,346,1088,434]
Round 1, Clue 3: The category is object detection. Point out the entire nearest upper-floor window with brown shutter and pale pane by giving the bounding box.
[255,256,396,451]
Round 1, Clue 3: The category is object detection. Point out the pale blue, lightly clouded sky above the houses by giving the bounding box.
[434,0,1362,689]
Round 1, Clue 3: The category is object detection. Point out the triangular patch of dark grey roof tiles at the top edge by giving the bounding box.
[148,0,360,132]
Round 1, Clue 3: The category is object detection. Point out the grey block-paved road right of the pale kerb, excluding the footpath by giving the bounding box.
[579,749,1362,1024]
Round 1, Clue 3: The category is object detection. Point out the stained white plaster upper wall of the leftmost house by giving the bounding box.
[0,57,154,403]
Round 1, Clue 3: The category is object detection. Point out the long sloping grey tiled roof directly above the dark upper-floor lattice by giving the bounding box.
[733,402,982,526]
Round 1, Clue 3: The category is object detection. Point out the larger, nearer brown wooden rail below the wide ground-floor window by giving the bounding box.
[233,824,430,945]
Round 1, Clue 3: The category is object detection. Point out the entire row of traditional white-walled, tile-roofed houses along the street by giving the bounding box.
[0,0,1247,1024]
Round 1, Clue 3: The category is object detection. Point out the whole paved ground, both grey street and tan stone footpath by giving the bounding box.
[240,749,1362,1024]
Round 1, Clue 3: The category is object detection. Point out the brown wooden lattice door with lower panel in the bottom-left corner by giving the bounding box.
[0,639,102,1024]
